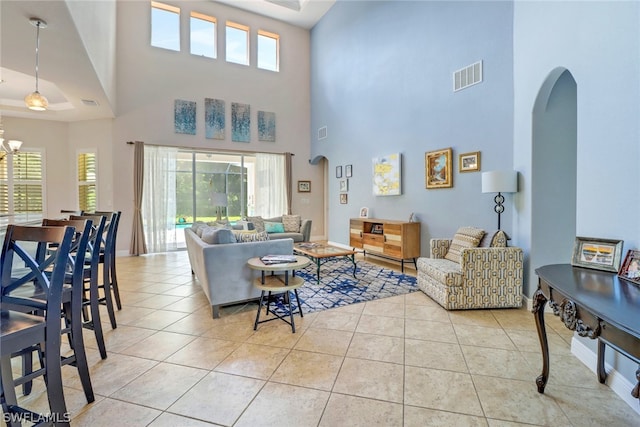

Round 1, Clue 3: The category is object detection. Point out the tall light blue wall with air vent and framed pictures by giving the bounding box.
[311,1,513,251]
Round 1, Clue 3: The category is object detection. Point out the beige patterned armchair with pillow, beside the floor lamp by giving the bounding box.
[417,239,524,310]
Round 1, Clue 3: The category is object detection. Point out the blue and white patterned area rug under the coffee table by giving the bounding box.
[268,258,419,314]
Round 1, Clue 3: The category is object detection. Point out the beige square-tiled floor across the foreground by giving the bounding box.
[10,252,640,427]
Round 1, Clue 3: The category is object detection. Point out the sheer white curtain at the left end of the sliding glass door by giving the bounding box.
[142,145,178,253]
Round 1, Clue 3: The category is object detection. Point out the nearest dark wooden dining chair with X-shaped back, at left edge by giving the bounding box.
[0,224,75,427]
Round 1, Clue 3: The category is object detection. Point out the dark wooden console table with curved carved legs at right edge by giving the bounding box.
[532,264,640,398]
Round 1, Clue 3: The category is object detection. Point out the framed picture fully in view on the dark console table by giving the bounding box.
[571,236,623,273]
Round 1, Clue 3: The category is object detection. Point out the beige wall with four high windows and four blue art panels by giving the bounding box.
[106,1,324,250]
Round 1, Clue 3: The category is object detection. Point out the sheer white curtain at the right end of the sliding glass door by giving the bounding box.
[255,153,287,218]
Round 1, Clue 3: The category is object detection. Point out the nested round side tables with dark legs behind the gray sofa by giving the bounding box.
[247,255,311,333]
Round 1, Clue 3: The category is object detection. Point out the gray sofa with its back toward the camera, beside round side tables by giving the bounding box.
[184,228,293,318]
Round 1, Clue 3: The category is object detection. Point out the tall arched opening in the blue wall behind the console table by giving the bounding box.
[529,67,578,282]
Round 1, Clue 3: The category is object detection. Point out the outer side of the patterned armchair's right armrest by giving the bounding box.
[460,247,524,292]
